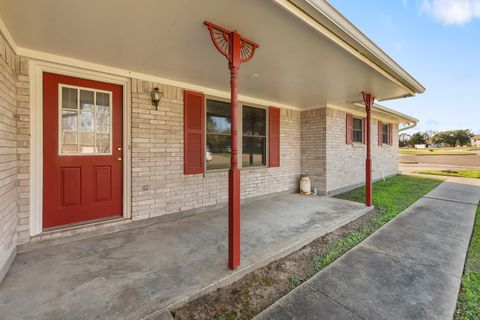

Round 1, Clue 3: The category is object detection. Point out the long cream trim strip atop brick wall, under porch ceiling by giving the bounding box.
[18,47,302,111]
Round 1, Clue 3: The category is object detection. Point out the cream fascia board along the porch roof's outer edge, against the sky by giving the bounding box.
[273,0,416,96]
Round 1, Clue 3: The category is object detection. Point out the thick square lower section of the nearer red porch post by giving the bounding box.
[228,168,240,270]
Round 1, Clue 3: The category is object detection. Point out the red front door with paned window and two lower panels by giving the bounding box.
[43,73,123,228]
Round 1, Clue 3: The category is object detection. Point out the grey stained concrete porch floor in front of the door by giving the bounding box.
[0,194,370,320]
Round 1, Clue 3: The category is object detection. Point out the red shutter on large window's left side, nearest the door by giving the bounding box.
[183,90,205,174]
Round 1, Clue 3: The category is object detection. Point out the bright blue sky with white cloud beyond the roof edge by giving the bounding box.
[329,0,480,134]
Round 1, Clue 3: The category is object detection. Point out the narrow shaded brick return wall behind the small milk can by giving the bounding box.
[301,108,327,194]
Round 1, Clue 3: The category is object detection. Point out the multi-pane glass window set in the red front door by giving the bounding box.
[58,85,112,155]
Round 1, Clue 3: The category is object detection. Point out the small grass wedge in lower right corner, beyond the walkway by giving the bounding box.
[455,205,480,320]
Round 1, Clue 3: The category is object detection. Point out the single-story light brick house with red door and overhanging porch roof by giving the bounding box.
[0,0,424,278]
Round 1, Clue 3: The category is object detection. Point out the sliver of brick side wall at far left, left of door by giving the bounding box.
[0,34,18,280]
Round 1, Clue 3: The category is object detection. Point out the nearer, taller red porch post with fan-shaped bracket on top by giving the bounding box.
[205,21,258,270]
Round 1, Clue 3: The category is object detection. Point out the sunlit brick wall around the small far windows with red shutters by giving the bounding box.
[326,108,398,192]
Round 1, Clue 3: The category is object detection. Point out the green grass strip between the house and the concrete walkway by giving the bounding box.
[312,175,443,270]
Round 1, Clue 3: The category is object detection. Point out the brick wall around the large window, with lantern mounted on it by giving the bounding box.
[132,79,301,219]
